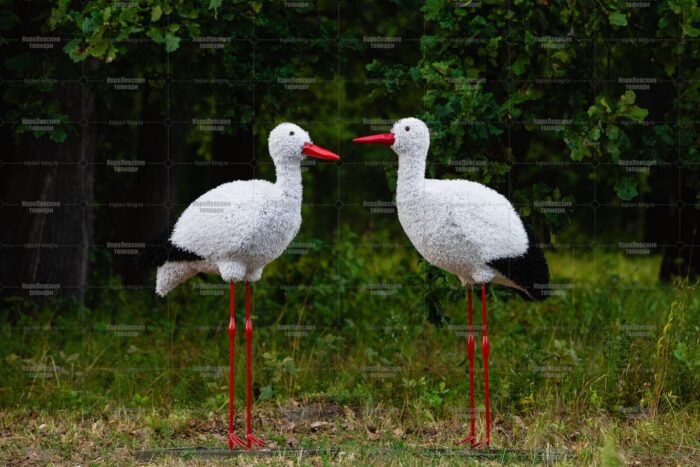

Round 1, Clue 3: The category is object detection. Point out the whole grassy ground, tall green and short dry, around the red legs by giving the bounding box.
[0,238,700,465]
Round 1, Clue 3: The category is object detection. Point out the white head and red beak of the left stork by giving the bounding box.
[267,123,340,163]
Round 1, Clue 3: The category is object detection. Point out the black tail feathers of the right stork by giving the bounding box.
[488,229,549,302]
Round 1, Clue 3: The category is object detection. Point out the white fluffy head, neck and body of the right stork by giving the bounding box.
[391,118,528,287]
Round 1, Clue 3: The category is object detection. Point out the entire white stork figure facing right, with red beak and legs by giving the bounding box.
[140,123,340,449]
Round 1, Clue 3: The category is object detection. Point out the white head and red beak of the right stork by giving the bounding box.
[353,117,430,158]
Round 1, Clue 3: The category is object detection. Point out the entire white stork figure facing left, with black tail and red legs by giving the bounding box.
[353,118,549,447]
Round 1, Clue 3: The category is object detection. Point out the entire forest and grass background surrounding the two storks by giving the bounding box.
[0,0,700,464]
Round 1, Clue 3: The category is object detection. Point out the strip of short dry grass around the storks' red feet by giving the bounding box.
[0,401,700,465]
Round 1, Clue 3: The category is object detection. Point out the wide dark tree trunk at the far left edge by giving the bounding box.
[0,62,96,300]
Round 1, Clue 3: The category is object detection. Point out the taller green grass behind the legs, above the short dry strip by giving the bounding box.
[0,250,700,422]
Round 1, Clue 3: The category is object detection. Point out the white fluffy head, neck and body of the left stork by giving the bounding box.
[156,123,311,296]
